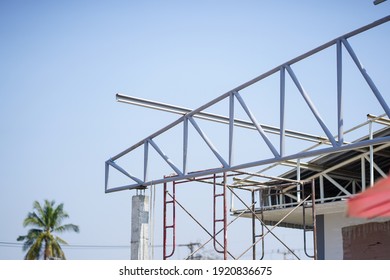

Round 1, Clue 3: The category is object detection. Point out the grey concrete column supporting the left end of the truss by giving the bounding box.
[131,194,149,260]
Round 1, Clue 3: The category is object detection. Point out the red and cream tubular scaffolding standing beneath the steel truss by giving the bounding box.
[163,172,316,260]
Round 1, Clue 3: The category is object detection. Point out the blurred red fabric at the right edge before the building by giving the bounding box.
[348,176,390,218]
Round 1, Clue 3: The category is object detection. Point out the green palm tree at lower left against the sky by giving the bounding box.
[17,200,79,260]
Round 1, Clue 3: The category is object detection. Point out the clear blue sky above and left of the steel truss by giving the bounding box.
[0,0,390,259]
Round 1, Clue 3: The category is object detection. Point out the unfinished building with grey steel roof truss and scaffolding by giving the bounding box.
[105,16,390,259]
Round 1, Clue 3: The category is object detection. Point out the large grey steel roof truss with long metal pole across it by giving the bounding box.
[105,16,390,193]
